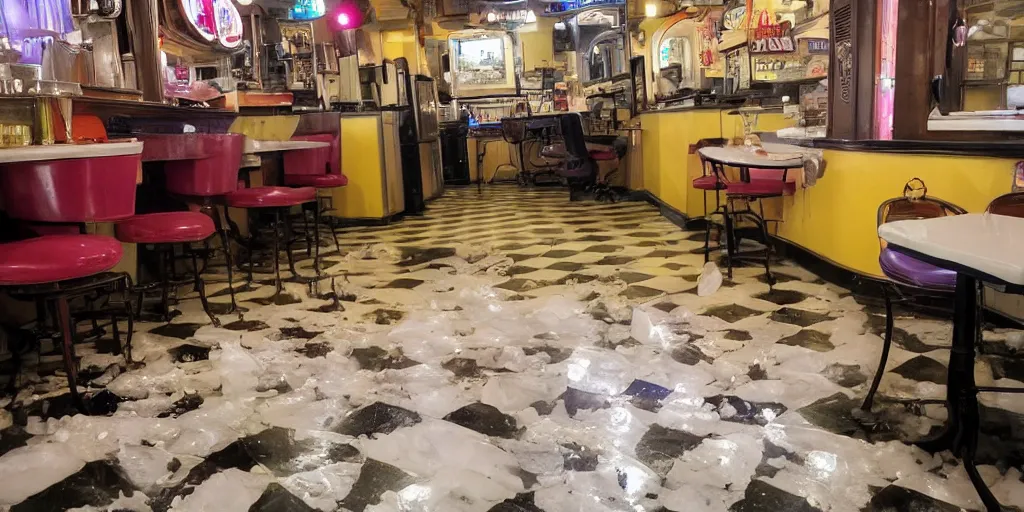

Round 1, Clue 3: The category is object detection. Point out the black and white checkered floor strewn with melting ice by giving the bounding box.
[0,187,1024,512]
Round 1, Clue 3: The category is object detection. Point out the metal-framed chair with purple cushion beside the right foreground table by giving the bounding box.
[860,178,967,411]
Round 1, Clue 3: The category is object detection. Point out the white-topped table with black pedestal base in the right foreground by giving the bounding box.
[879,214,1024,512]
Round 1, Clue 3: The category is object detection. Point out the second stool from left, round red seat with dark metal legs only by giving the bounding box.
[117,212,219,326]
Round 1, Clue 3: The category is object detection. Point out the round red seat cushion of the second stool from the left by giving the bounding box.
[117,212,214,244]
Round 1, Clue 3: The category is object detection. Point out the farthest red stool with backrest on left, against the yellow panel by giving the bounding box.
[285,133,348,256]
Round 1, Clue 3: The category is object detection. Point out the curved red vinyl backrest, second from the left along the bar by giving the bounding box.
[163,133,246,198]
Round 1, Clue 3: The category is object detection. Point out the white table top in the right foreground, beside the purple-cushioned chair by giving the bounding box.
[879,213,1024,285]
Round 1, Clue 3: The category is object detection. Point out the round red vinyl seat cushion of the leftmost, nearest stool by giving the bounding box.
[0,234,123,286]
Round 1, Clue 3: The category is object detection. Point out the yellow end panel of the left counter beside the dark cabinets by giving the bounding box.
[331,116,384,218]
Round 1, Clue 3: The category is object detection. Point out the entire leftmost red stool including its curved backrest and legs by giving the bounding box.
[0,143,142,411]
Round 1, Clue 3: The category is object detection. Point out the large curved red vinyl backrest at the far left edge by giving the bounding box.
[0,155,141,222]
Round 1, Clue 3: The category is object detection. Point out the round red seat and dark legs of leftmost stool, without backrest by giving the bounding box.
[0,234,126,414]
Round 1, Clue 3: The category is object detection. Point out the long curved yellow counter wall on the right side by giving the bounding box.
[640,110,1017,276]
